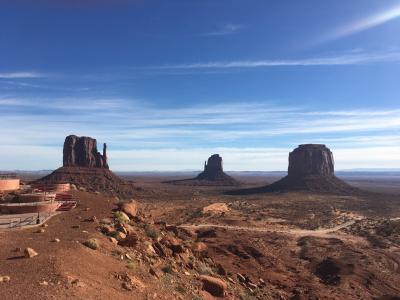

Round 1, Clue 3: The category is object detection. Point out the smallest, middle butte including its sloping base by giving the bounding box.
[168,154,240,186]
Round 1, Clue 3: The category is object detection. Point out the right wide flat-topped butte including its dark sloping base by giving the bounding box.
[227,144,358,195]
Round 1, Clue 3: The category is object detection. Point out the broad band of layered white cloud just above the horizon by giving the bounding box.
[0,97,400,170]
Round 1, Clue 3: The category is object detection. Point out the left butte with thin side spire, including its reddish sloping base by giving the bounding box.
[35,135,136,198]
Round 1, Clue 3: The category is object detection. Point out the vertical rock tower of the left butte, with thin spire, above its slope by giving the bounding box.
[63,135,108,169]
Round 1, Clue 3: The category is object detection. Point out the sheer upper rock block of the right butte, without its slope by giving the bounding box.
[288,144,334,177]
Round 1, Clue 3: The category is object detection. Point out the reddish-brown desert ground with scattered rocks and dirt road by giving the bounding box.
[0,175,400,300]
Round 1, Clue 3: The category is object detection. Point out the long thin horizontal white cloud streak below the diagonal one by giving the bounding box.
[147,52,400,70]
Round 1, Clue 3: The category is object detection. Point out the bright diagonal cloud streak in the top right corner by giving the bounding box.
[317,5,400,43]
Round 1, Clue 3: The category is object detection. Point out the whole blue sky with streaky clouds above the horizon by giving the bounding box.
[0,0,400,171]
